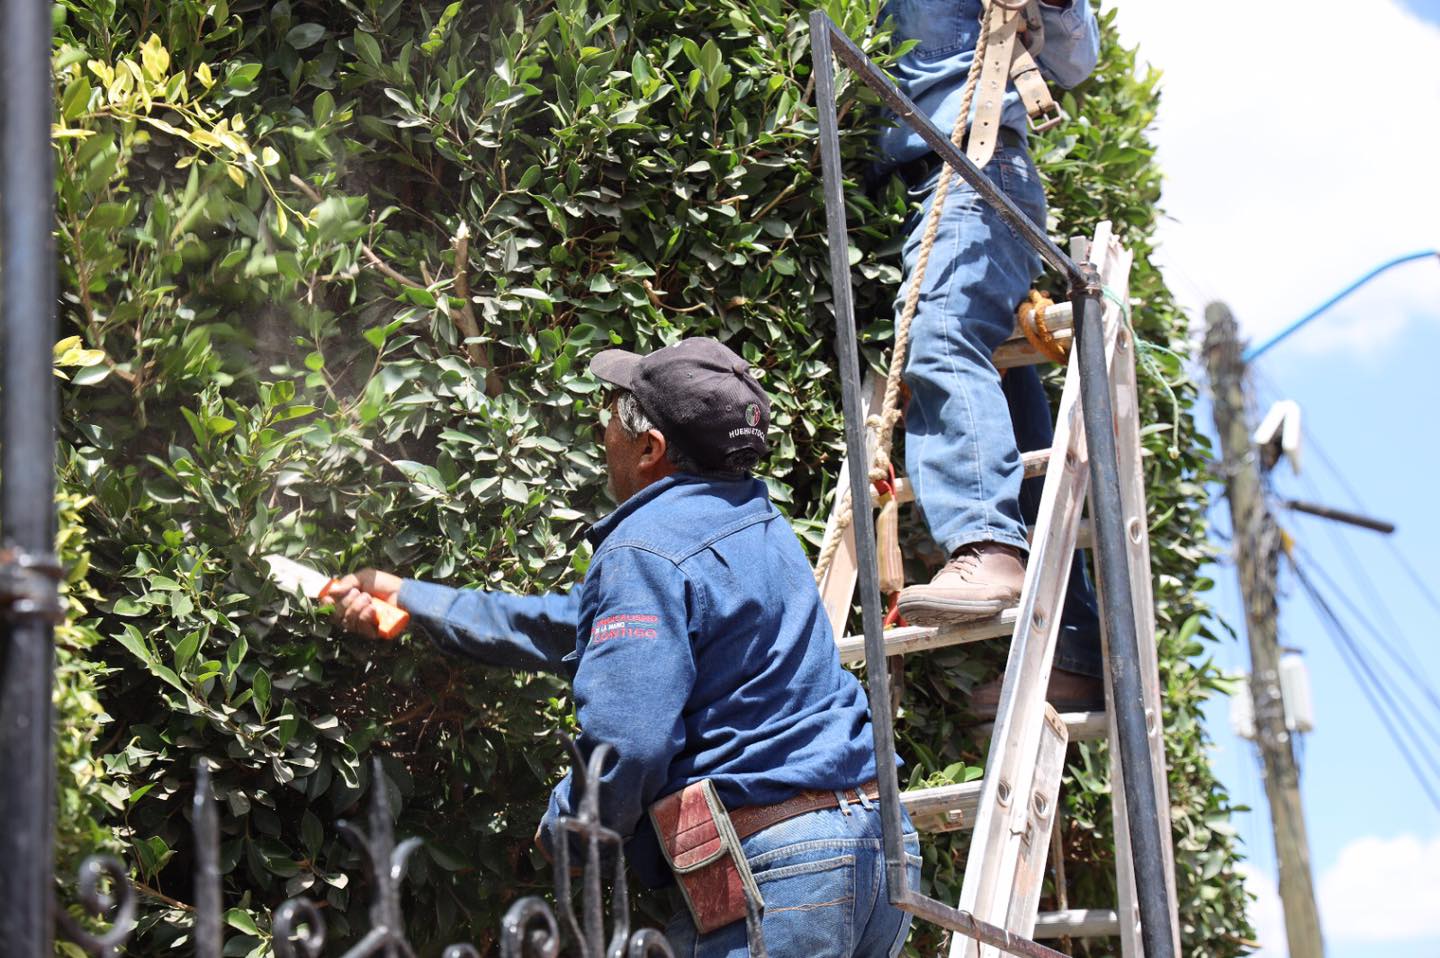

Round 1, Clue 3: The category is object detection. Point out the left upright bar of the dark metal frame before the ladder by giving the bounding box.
[811,10,910,902]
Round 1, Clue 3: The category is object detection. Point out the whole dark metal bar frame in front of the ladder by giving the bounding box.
[809,10,1175,958]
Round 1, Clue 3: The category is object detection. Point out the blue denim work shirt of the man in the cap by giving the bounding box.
[399,474,876,886]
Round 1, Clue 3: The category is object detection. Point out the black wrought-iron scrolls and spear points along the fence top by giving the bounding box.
[55,738,691,958]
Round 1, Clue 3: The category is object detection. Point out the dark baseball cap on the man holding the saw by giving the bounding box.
[590,337,770,470]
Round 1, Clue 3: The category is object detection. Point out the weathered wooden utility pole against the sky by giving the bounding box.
[1205,303,1325,958]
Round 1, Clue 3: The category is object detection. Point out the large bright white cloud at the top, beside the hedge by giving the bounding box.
[1107,0,1440,358]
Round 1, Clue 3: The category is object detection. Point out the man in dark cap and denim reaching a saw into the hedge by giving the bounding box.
[336,339,919,958]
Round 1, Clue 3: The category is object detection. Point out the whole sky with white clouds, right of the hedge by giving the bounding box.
[1106,0,1440,958]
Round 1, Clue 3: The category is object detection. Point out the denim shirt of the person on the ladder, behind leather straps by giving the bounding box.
[877,0,1100,169]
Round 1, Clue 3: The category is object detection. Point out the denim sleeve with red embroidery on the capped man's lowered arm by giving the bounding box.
[541,546,697,849]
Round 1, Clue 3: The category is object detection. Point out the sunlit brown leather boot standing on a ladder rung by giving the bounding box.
[900,542,1025,625]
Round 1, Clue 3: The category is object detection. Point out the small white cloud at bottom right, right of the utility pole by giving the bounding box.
[1318,836,1440,944]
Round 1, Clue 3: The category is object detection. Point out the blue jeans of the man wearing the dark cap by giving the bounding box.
[665,800,920,958]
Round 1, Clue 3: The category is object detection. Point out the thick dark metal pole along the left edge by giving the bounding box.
[0,0,56,958]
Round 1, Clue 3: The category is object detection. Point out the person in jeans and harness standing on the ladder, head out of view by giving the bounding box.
[878,0,1103,717]
